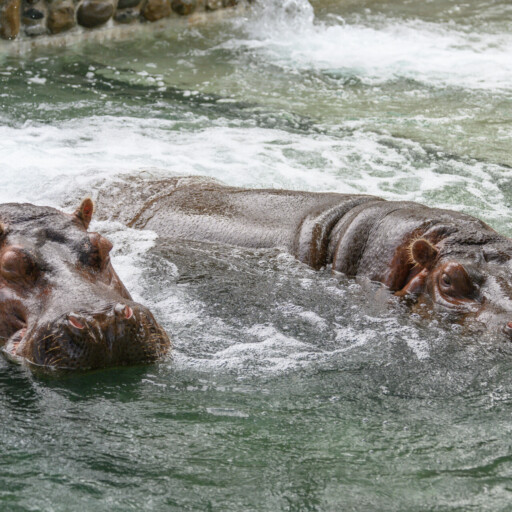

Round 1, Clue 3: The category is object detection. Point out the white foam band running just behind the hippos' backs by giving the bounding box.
[0,116,512,229]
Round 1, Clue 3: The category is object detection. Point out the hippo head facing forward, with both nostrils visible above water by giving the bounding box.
[0,199,170,369]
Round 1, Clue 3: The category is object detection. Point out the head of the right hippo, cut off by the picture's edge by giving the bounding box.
[399,233,512,337]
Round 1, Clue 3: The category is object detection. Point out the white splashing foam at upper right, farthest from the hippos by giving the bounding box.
[226,0,512,90]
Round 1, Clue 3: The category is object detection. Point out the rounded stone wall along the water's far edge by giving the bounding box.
[0,0,248,42]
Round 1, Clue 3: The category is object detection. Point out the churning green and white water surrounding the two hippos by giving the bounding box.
[0,0,512,511]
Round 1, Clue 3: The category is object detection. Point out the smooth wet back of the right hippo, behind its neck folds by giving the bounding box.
[98,177,382,268]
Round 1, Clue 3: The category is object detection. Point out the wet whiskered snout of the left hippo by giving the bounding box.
[5,301,170,369]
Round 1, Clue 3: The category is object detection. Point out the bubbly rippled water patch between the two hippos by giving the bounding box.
[107,236,496,384]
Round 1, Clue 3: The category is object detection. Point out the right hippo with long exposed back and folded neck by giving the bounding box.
[95,177,512,336]
